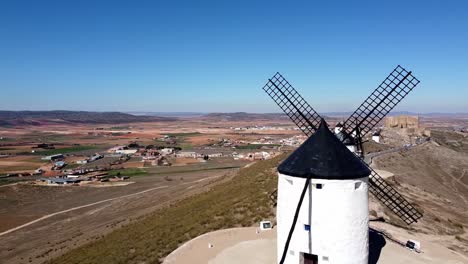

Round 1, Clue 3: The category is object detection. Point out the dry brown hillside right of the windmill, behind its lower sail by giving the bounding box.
[370,134,468,256]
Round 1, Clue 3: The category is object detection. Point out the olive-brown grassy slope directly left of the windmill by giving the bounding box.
[48,155,285,264]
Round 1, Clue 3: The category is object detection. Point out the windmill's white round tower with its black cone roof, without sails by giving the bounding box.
[276,120,370,264]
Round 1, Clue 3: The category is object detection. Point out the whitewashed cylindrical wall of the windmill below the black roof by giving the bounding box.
[277,174,369,264]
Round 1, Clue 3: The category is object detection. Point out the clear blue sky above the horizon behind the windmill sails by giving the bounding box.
[0,0,468,112]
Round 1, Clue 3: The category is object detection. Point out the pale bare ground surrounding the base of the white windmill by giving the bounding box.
[163,223,468,264]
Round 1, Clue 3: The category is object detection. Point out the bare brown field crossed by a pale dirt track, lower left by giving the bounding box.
[0,167,239,263]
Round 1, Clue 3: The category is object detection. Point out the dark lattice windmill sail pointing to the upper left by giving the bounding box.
[263,72,321,136]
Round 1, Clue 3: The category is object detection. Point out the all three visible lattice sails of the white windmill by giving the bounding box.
[263,65,422,225]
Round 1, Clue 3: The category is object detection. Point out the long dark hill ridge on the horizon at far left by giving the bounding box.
[0,110,176,126]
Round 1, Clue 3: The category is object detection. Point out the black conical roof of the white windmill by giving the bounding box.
[278,119,370,180]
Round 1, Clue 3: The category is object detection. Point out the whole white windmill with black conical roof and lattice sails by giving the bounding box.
[263,65,422,264]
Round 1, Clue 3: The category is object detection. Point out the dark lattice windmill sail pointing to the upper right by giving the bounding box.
[343,65,419,137]
